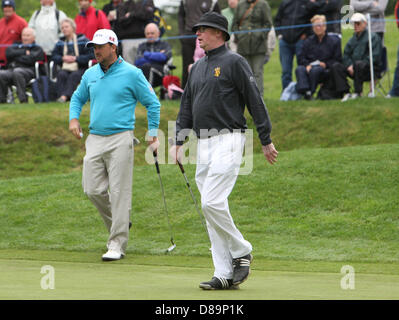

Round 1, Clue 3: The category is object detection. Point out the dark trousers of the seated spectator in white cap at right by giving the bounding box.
[331,61,380,94]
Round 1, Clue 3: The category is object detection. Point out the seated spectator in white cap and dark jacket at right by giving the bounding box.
[331,13,382,101]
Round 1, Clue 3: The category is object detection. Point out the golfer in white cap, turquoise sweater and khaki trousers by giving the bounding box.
[69,29,160,261]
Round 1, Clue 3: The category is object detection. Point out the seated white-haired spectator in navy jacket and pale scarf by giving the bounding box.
[52,18,94,102]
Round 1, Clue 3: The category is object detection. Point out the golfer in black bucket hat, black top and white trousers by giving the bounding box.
[170,12,277,290]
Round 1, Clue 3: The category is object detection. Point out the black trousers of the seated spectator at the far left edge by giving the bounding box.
[0,68,35,103]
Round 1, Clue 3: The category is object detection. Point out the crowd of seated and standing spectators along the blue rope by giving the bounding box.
[0,0,399,103]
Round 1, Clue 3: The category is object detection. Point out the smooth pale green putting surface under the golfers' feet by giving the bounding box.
[0,250,399,300]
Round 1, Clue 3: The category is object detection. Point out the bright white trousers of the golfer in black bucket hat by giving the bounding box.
[195,133,252,279]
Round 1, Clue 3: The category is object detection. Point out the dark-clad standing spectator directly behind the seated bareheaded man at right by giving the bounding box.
[309,0,342,35]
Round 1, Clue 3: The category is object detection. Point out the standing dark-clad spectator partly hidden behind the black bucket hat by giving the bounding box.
[178,0,220,88]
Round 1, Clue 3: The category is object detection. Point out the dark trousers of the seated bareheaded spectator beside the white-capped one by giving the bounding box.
[295,66,328,94]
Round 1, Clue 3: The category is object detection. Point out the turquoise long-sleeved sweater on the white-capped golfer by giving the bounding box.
[69,57,161,137]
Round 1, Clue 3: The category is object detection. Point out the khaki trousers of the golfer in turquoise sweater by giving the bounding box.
[82,131,134,254]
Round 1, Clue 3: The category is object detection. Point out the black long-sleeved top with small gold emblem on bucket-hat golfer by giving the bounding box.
[176,45,271,145]
